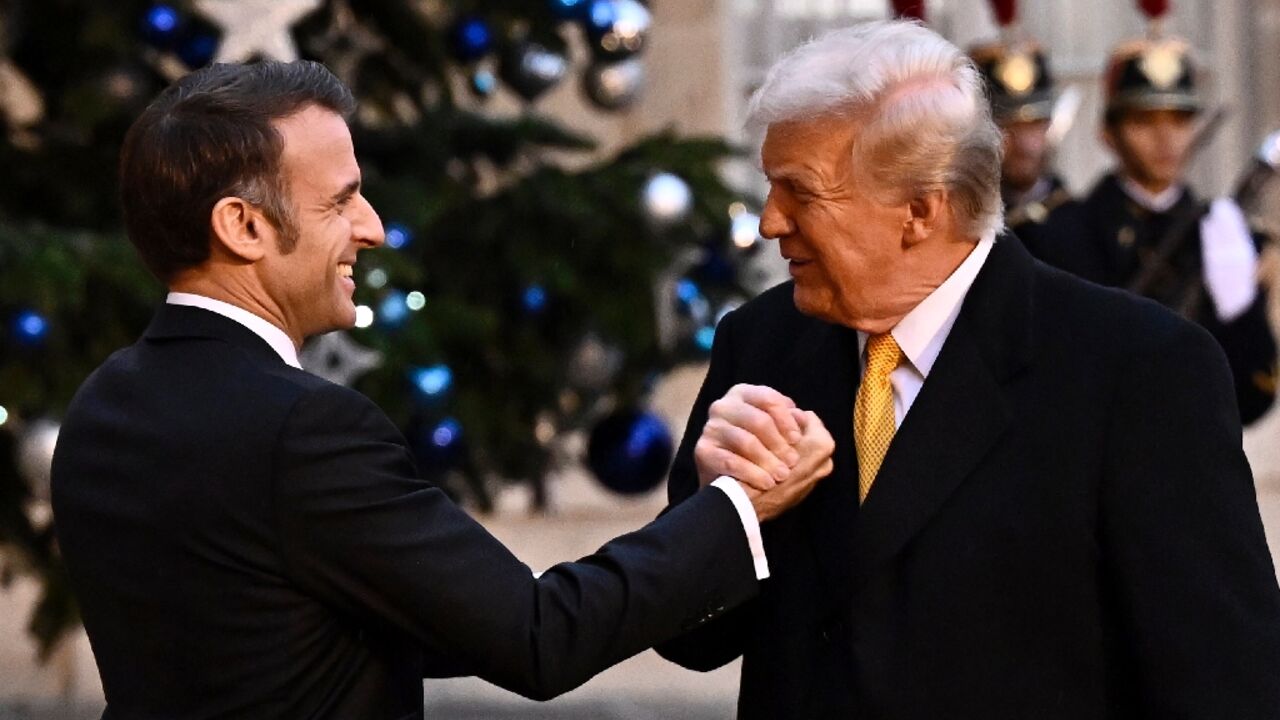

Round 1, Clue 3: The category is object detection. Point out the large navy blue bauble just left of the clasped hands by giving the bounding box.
[586,410,675,495]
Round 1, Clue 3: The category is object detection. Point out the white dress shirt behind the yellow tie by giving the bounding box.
[858,230,996,428]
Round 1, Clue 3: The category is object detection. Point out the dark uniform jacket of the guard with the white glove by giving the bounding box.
[1070,174,1276,424]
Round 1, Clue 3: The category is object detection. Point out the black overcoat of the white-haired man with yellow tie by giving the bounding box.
[660,237,1280,720]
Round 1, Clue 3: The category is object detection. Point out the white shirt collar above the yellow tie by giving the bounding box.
[858,234,996,378]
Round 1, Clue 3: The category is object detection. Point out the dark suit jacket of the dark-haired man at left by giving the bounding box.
[52,305,758,719]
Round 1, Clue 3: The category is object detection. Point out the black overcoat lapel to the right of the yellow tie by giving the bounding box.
[854,240,1034,584]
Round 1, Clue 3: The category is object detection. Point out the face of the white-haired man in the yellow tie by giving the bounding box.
[760,118,972,333]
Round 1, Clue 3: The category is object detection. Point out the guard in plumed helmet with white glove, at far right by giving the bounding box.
[1056,37,1276,424]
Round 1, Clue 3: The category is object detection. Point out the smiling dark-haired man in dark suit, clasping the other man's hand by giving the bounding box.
[52,63,831,719]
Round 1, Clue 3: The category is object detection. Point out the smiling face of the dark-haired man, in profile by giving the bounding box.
[255,105,384,343]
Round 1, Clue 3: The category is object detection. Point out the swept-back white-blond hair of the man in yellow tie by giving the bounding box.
[748,20,1004,237]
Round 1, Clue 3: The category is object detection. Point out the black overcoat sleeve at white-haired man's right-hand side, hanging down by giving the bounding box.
[1100,322,1280,720]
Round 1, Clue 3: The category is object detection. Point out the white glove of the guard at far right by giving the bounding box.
[1201,197,1258,323]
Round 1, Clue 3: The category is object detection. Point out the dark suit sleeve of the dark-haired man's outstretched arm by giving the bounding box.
[266,386,758,698]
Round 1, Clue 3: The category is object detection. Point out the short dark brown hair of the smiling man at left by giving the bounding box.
[120,60,356,282]
